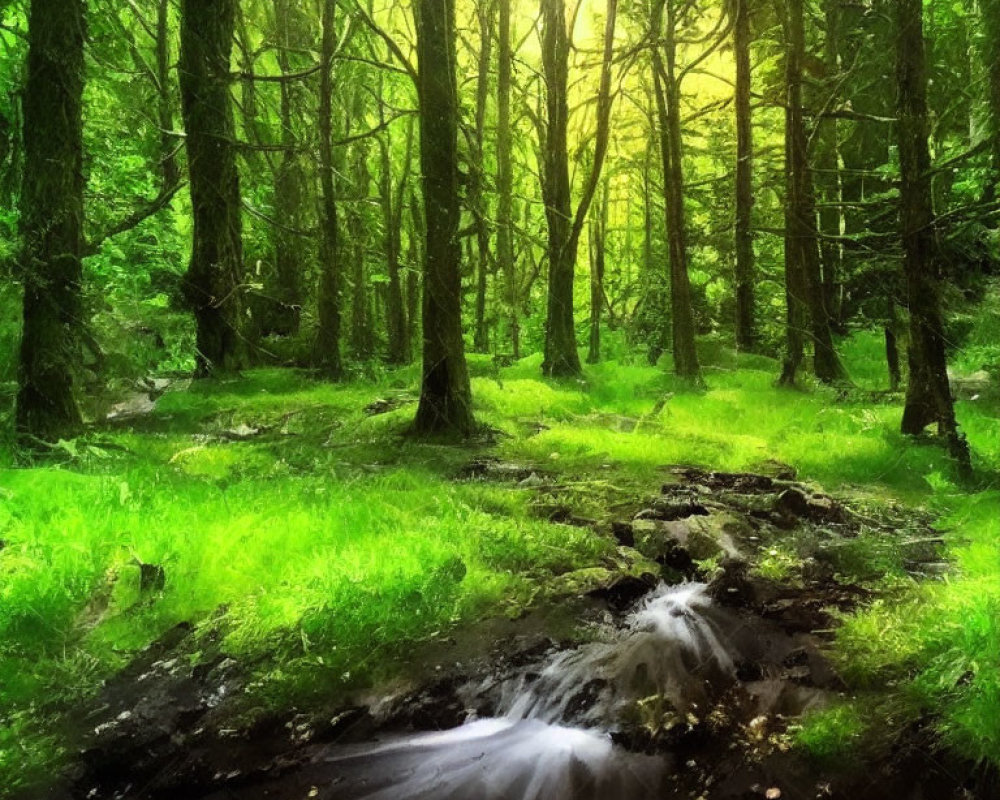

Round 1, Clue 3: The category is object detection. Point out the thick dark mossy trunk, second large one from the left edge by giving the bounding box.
[179,0,244,377]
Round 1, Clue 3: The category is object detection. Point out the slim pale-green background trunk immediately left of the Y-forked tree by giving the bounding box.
[497,0,521,358]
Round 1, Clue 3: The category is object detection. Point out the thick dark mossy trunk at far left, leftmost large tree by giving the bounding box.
[16,0,85,440]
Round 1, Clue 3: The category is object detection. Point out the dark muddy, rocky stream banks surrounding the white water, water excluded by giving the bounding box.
[25,468,998,800]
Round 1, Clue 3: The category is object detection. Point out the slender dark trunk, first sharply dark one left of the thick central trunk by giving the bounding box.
[314,0,344,380]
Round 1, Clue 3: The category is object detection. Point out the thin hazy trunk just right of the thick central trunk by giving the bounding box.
[468,0,493,353]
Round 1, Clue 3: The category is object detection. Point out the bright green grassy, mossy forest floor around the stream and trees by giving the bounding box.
[0,328,1000,797]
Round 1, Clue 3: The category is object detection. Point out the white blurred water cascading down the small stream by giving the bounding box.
[321,583,735,800]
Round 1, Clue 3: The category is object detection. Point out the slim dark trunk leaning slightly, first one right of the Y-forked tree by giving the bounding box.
[652,0,701,382]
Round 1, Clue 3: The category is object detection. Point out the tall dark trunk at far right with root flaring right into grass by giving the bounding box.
[895,0,971,473]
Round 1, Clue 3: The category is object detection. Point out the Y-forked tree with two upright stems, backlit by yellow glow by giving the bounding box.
[542,0,618,377]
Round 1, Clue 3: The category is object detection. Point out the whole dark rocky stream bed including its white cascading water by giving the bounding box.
[39,465,987,800]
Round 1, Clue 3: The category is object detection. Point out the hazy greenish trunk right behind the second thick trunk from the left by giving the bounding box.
[267,0,305,336]
